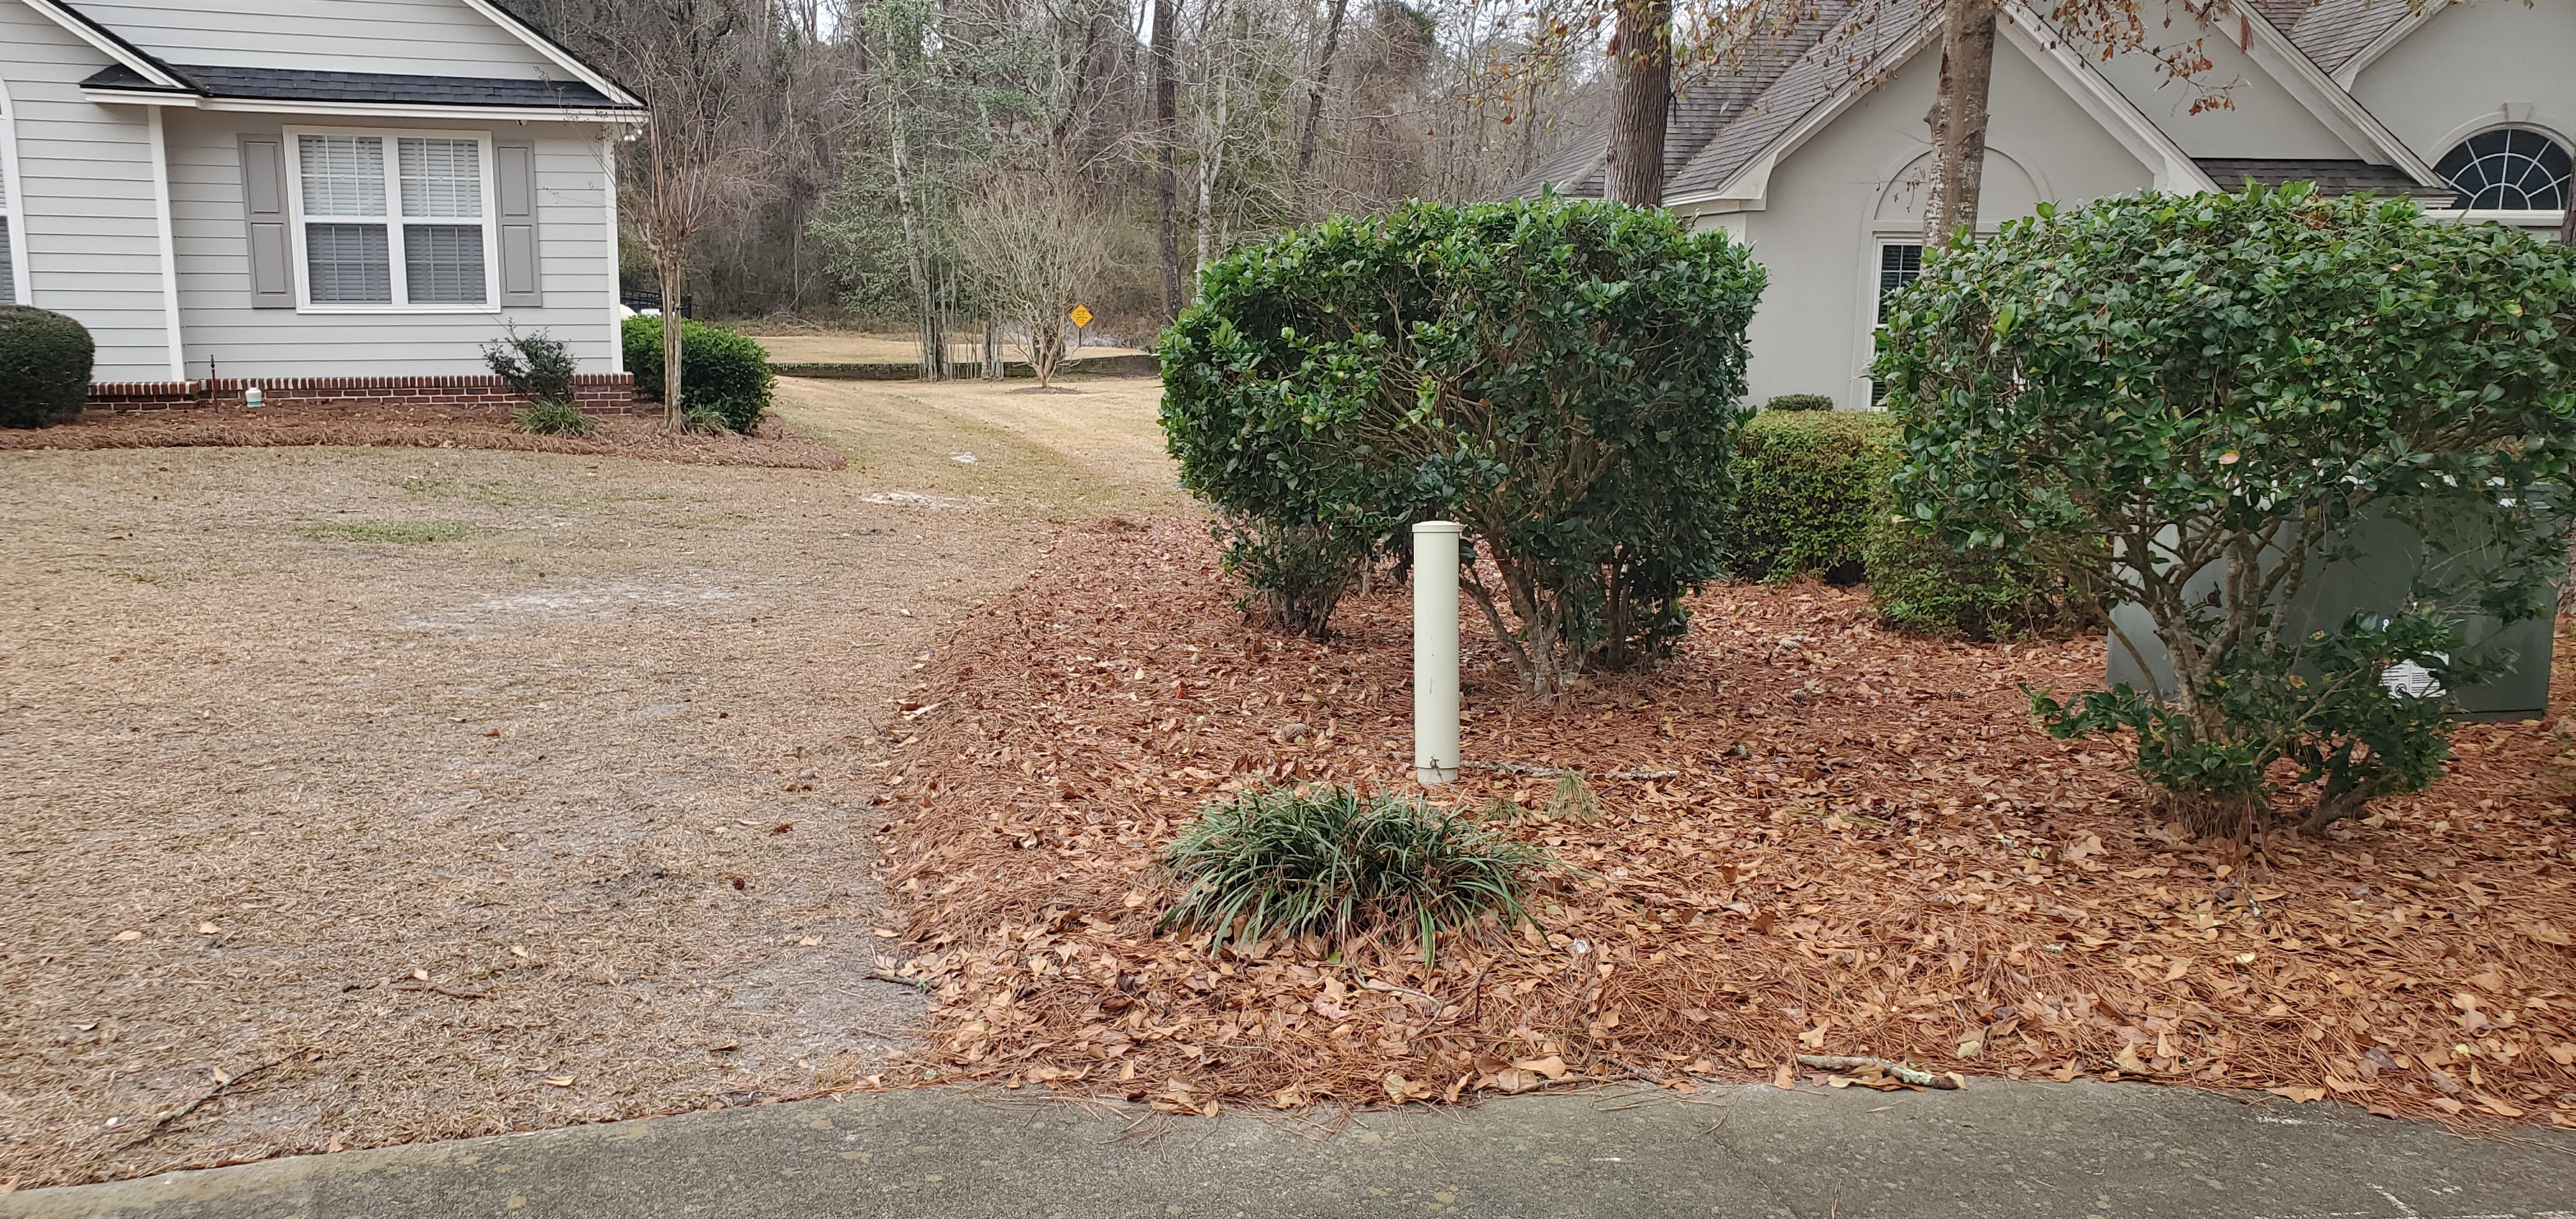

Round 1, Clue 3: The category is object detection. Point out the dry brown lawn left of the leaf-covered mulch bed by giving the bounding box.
[0,368,1175,1186]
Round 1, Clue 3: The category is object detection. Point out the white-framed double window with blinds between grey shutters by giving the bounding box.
[286,132,500,309]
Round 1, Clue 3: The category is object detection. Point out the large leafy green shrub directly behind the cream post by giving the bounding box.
[1162,196,1762,696]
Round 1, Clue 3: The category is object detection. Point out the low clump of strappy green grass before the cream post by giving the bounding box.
[1162,786,1563,964]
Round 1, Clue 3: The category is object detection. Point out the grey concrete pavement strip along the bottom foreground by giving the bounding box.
[15,1080,2576,1219]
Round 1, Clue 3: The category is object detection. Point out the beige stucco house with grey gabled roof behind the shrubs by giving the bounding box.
[1515,0,2576,410]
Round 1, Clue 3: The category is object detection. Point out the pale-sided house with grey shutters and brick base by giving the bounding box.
[0,0,641,381]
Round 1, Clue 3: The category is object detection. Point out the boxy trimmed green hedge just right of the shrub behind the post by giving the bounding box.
[1726,410,1901,585]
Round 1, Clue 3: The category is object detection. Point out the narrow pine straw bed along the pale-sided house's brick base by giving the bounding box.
[0,402,850,469]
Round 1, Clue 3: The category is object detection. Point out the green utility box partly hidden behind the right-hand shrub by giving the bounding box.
[2110,489,2568,719]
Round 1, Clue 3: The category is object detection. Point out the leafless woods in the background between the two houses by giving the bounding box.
[515,0,1607,351]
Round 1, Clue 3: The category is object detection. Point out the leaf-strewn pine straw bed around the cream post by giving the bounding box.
[881,521,2576,1129]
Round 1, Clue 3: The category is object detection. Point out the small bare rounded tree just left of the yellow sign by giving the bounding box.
[958,175,1105,389]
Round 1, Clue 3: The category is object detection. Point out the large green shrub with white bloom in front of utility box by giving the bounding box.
[1875,185,2576,832]
